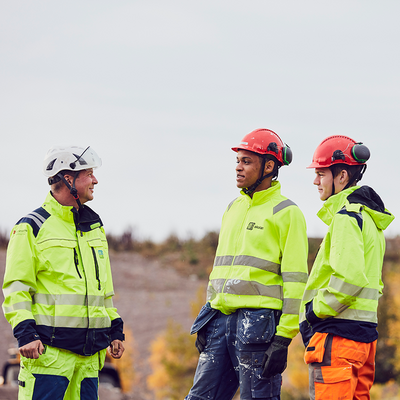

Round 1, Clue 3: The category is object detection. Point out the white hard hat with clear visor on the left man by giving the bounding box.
[43,146,101,178]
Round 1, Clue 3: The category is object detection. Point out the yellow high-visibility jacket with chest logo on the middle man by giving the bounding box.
[207,181,308,339]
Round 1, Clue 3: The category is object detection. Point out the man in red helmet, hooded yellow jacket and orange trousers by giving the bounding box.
[300,136,394,400]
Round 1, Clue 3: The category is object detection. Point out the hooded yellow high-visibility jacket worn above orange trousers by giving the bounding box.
[300,186,394,344]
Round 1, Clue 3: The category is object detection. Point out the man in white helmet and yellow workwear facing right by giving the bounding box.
[3,146,124,400]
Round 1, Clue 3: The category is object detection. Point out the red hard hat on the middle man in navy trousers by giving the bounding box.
[232,129,292,165]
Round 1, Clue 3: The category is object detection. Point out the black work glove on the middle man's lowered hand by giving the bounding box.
[262,336,292,379]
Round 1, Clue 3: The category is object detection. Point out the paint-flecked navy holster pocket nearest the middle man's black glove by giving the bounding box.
[236,308,276,344]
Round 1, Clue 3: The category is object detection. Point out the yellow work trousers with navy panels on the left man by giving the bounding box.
[18,345,106,400]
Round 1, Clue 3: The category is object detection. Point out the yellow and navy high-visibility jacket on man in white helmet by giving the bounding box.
[3,193,124,355]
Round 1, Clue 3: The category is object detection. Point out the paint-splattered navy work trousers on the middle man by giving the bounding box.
[185,306,282,400]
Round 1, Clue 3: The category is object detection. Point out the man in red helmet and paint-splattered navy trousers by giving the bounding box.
[186,129,308,400]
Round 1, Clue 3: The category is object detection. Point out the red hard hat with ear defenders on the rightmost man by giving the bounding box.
[307,135,370,168]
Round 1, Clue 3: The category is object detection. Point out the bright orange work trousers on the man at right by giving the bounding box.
[304,332,376,400]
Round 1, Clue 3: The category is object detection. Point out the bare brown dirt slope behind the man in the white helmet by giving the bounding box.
[0,250,206,400]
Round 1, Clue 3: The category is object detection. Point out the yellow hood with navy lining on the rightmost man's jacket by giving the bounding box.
[317,186,394,230]
